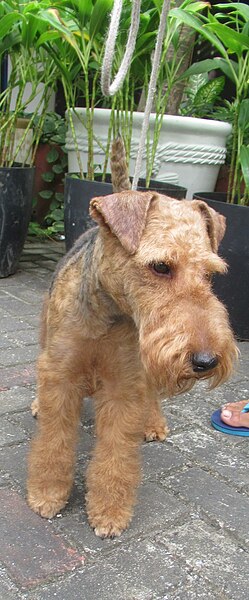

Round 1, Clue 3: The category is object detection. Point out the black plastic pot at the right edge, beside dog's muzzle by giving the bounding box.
[194,192,249,340]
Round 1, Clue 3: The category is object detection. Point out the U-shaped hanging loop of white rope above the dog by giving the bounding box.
[101,0,141,96]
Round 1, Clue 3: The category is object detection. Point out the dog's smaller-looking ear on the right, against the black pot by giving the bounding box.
[192,200,226,252]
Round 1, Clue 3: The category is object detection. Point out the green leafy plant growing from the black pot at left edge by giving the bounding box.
[0,0,57,166]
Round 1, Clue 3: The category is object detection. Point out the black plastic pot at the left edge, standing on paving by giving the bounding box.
[0,167,35,277]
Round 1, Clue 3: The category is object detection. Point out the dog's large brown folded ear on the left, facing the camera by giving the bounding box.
[90,190,155,254]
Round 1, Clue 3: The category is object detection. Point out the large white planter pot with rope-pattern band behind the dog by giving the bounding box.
[66,108,231,198]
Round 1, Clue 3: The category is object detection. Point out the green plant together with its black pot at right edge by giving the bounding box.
[175,2,249,339]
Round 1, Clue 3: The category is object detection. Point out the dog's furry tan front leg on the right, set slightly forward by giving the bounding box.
[86,382,147,537]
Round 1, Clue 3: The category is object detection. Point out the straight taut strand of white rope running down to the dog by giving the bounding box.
[132,0,170,190]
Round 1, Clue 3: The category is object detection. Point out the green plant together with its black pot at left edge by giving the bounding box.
[0,2,56,277]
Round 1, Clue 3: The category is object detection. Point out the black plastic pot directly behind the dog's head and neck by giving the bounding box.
[64,175,113,251]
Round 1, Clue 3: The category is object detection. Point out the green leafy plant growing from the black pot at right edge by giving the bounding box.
[171,2,249,205]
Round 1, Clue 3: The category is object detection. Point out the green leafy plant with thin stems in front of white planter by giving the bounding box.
[29,0,207,179]
